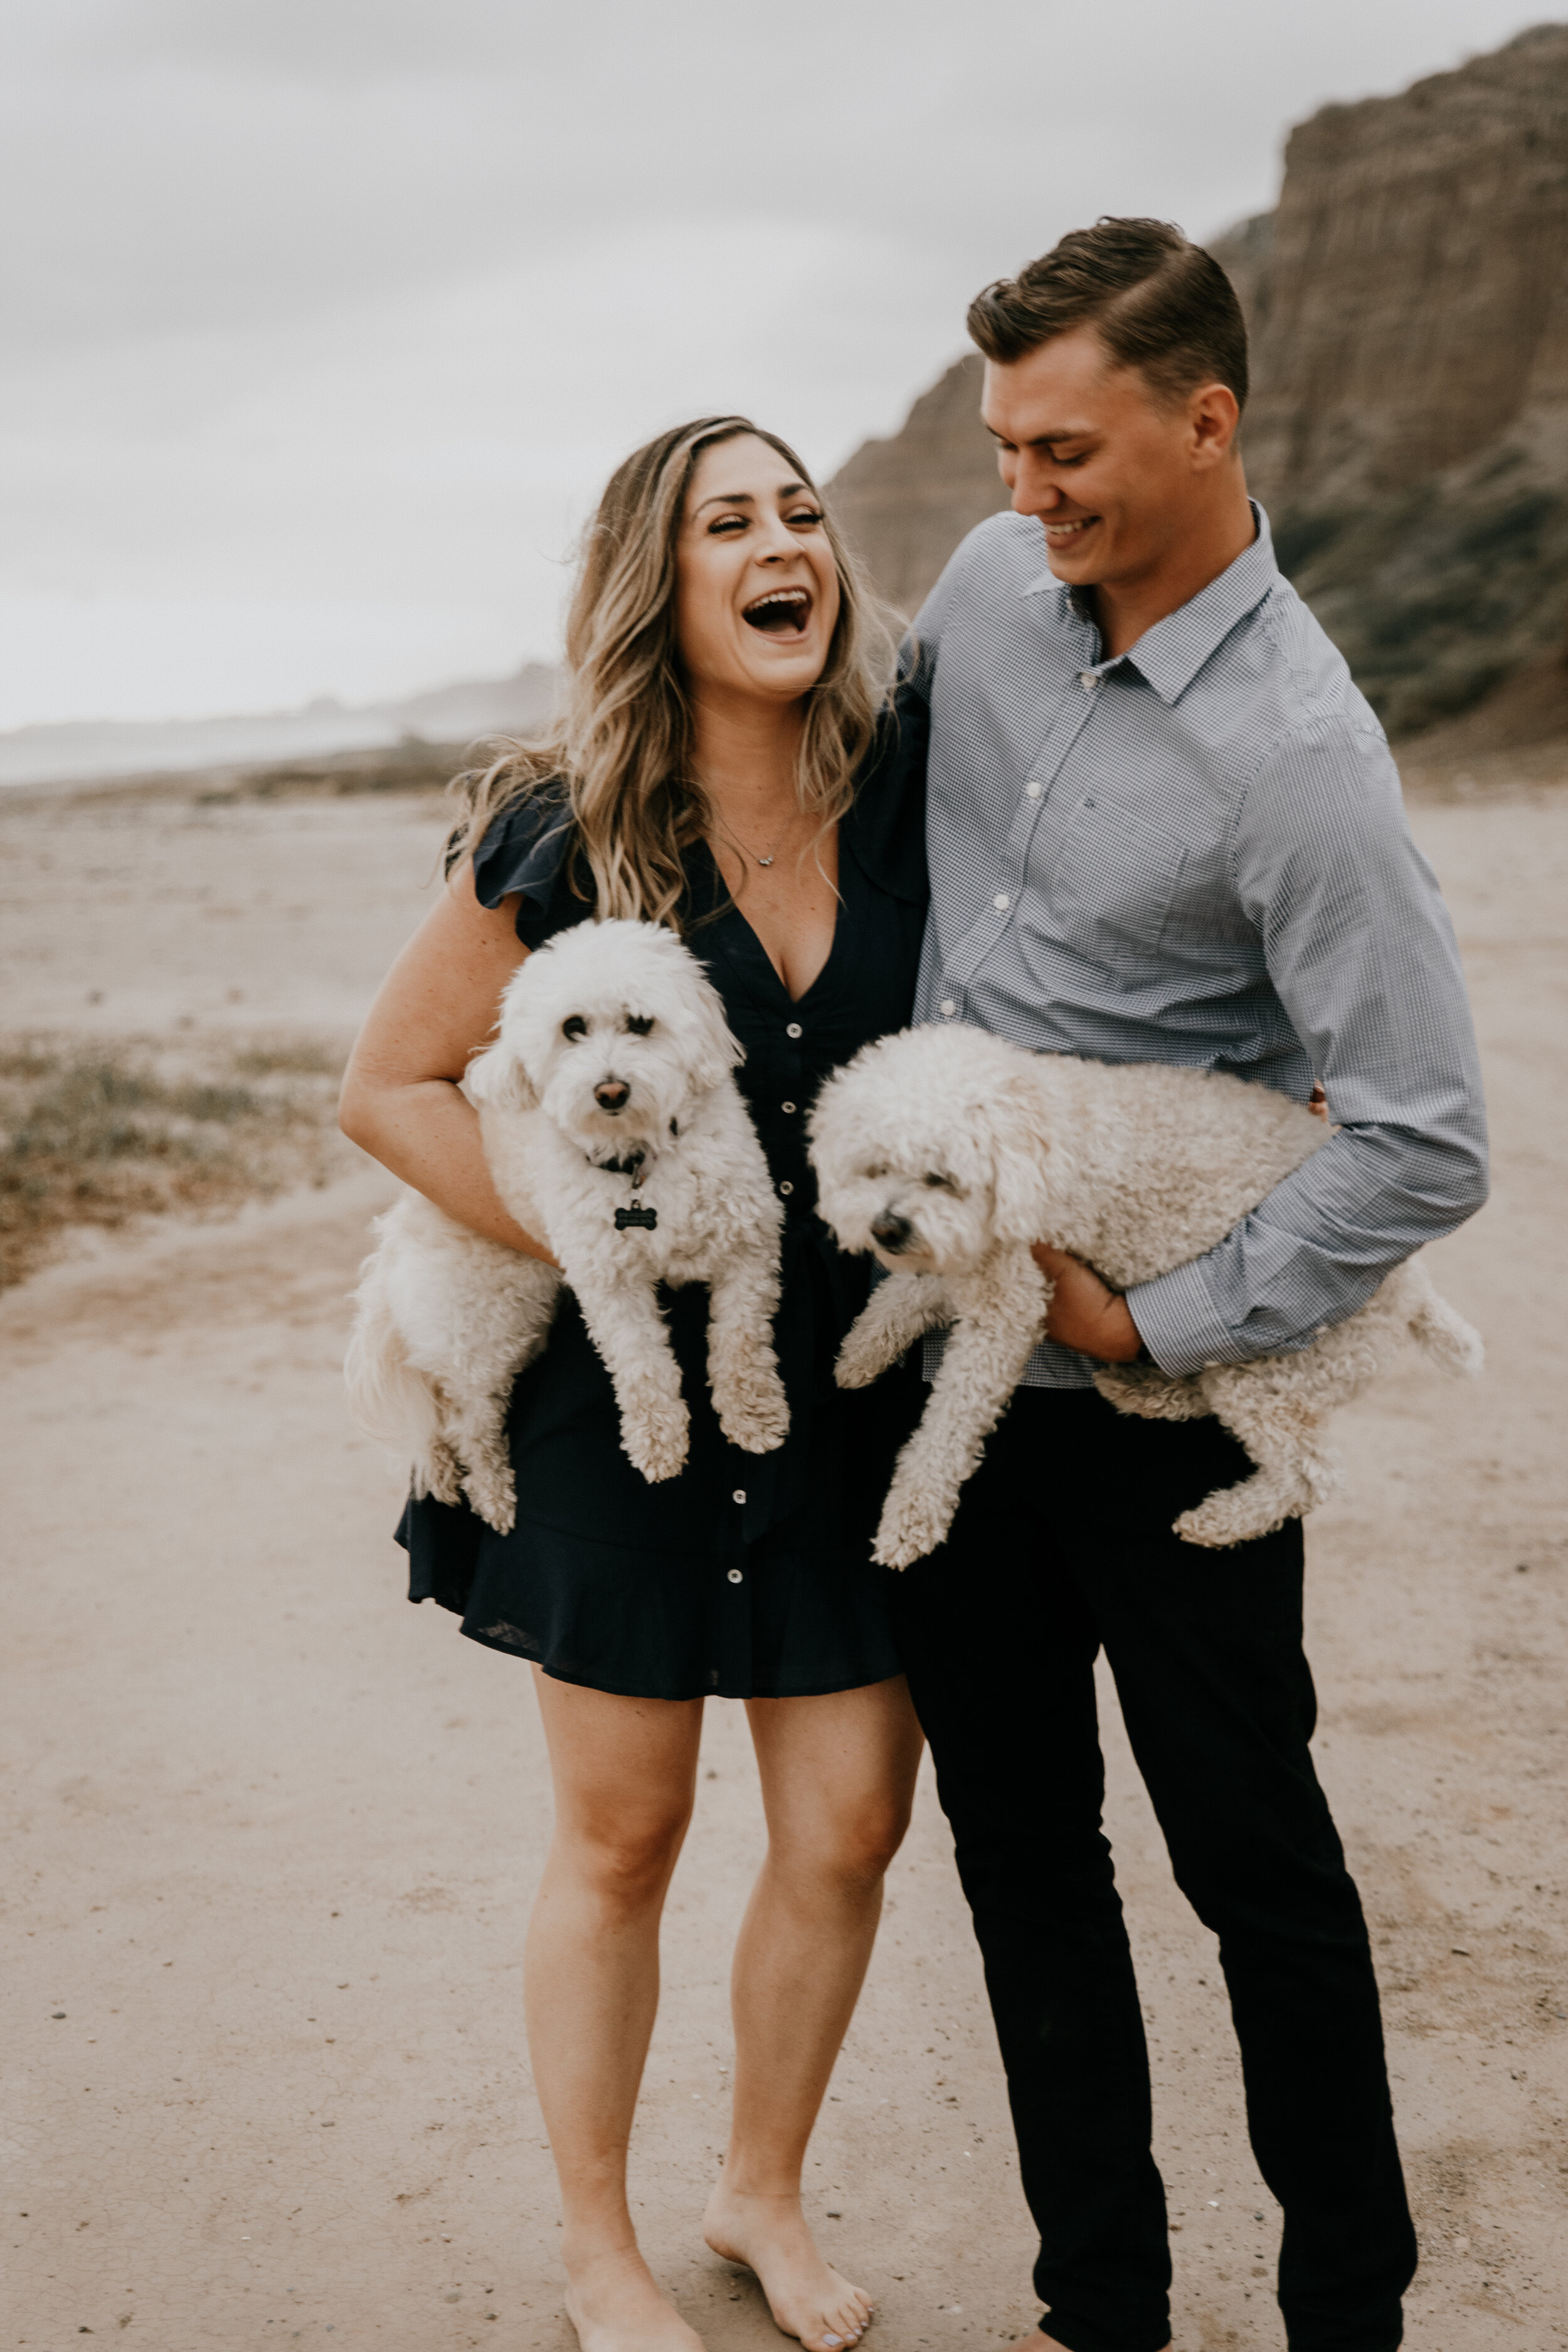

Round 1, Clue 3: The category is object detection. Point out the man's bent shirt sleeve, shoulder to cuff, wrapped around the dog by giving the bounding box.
[1114,715,1486,1374]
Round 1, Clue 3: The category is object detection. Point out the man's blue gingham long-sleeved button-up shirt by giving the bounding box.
[908,508,1486,1388]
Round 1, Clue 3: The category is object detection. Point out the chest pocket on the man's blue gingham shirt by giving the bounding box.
[1022,793,1187,965]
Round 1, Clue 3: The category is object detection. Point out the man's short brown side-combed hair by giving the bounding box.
[968,214,1246,407]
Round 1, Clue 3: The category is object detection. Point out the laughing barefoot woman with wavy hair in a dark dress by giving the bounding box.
[343,416,926,2352]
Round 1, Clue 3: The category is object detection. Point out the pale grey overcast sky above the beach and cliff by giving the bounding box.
[0,0,1564,727]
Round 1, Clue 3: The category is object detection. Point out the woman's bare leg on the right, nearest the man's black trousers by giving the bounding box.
[703,1675,921,2352]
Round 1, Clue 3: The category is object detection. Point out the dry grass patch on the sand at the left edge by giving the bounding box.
[0,1037,352,1286]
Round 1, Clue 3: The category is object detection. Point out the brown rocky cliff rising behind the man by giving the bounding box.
[832,26,1568,734]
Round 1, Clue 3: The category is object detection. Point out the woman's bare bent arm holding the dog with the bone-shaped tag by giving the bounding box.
[339,859,555,1263]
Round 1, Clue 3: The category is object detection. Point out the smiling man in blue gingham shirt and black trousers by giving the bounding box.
[898,219,1486,2352]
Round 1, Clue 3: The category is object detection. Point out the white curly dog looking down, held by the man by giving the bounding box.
[811,1023,1481,1569]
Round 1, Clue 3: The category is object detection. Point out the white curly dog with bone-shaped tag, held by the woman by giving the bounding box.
[346,922,790,1534]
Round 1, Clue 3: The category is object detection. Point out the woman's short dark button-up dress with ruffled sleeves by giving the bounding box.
[397,703,926,1698]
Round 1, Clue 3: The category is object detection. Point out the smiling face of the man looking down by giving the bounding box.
[980,327,1234,588]
